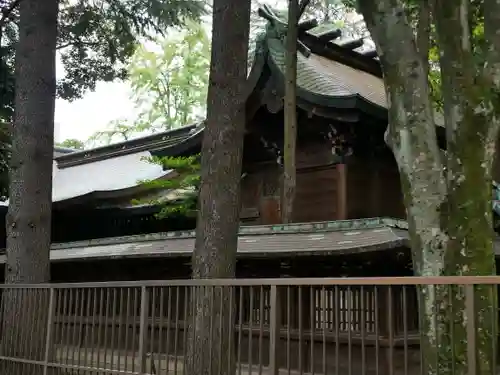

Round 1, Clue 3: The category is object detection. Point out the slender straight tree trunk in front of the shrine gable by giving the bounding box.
[281,0,299,223]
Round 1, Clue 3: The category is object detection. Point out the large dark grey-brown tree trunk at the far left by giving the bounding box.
[2,0,58,375]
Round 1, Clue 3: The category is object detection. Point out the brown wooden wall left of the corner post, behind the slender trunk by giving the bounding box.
[241,141,345,225]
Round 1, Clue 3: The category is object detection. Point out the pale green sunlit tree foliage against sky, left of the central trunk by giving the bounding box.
[90,21,210,144]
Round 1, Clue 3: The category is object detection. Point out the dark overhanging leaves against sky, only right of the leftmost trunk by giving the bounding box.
[58,0,204,99]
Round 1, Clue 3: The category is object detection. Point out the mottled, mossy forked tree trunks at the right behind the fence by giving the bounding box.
[358,0,500,374]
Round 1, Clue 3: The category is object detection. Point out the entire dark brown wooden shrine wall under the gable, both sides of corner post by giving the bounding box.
[242,141,406,225]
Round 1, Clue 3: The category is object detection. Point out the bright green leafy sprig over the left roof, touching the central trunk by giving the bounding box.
[132,155,200,219]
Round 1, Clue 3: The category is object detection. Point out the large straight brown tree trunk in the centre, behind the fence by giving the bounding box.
[187,0,250,375]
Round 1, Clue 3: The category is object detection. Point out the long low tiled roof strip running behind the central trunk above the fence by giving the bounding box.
[0,218,406,263]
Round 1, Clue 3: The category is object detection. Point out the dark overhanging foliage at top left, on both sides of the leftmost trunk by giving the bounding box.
[0,0,206,200]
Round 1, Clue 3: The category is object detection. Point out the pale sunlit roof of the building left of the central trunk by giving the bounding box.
[0,125,203,206]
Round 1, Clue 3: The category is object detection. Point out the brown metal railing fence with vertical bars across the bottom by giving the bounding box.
[0,277,500,375]
